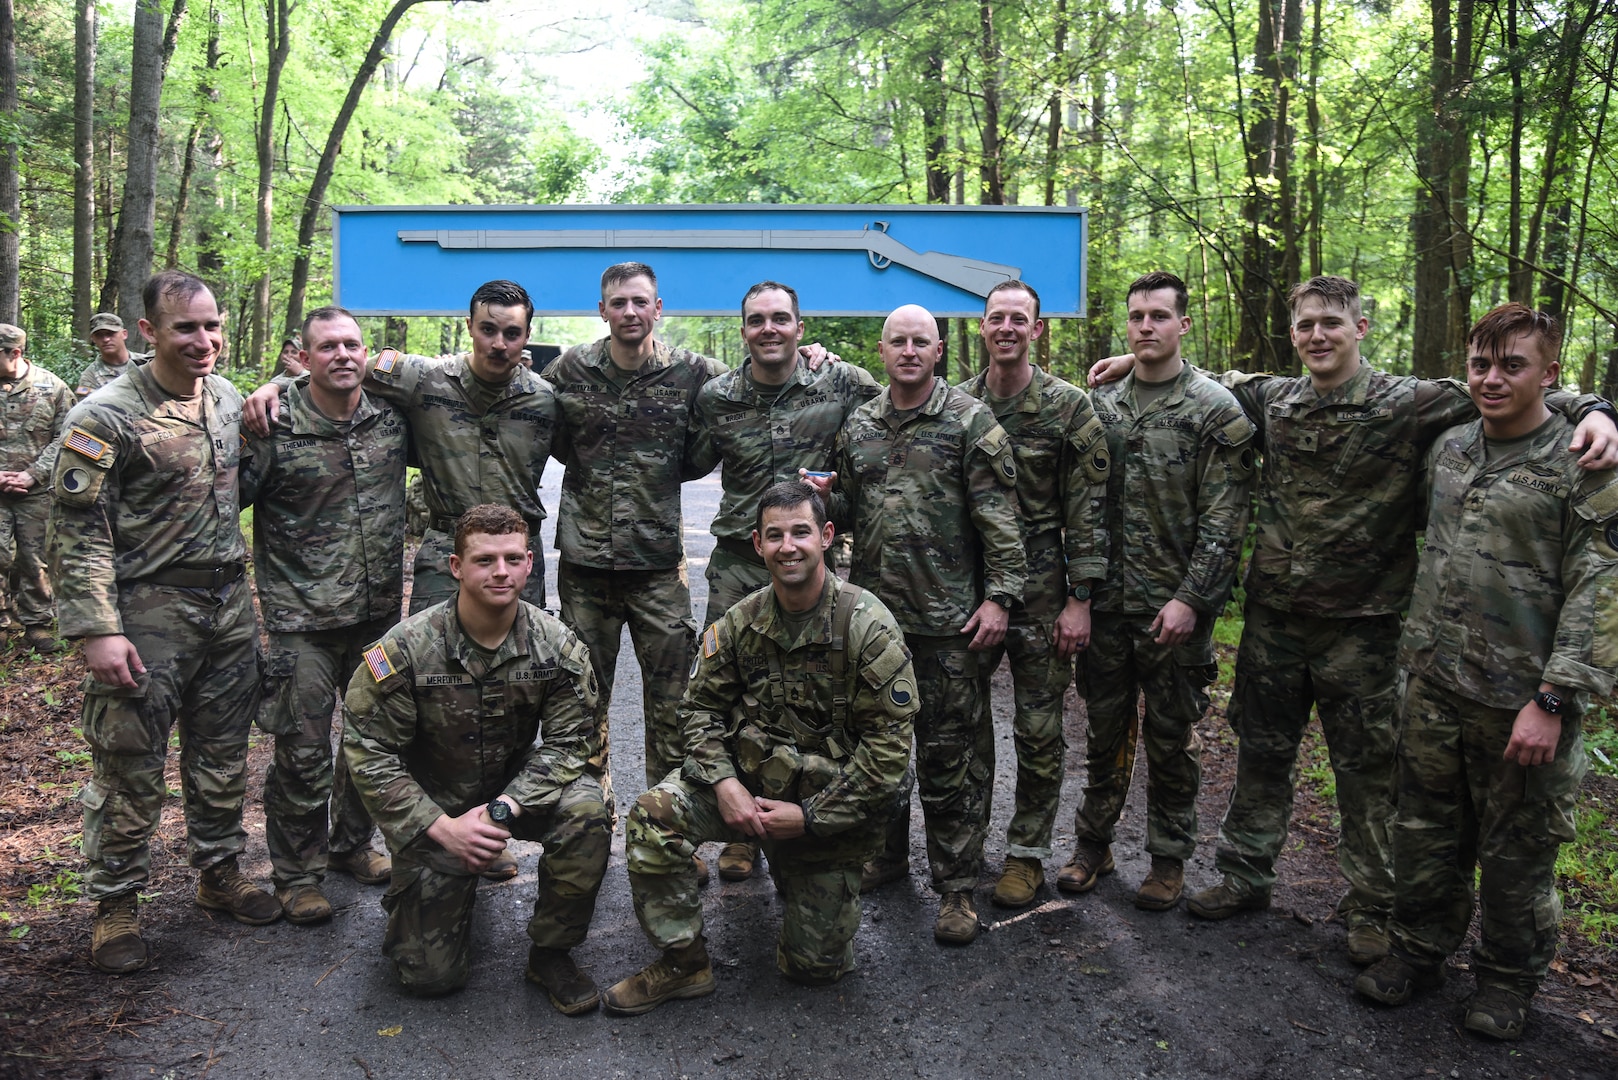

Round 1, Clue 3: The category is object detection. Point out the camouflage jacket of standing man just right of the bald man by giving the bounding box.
[961,368,1112,615]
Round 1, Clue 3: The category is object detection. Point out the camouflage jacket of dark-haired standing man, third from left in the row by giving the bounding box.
[366,348,557,536]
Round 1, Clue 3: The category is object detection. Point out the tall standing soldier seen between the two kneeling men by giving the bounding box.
[545,262,725,787]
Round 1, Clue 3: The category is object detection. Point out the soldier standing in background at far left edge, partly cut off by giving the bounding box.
[0,322,73,653]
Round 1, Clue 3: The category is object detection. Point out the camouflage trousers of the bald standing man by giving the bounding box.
[883,633,995,892]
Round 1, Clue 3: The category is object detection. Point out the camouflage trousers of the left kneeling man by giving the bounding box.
[382,776,612,997]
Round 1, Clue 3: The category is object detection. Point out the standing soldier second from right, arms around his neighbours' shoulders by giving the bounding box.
[1087,277,1612,965]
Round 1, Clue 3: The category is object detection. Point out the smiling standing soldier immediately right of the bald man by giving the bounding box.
[961,280,1108,907]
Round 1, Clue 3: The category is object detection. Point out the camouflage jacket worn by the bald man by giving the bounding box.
[832,379,1027,636]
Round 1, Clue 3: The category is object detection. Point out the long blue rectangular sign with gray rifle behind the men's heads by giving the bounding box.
[332,206,1089,317]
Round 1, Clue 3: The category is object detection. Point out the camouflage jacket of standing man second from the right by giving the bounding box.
[1217,364,1600,619]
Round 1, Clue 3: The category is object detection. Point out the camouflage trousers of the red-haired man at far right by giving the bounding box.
[1388,675,1586,996]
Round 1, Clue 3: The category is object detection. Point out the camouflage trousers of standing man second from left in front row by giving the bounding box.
[259,619,398,889]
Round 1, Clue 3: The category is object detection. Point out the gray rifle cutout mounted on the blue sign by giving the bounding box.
[400,222,1023,296]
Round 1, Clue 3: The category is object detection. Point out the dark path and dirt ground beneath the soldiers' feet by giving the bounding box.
[0,481,1618,1080]
